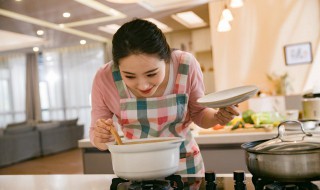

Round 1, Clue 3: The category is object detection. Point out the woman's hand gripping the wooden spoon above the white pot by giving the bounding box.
[93,119,114,150]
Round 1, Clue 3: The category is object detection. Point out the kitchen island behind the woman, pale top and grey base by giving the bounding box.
[78,130,277,174]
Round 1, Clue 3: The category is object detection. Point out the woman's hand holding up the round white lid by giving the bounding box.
[215,105,240,125]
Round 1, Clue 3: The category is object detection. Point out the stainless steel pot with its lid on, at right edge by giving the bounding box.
[241,121,320,182]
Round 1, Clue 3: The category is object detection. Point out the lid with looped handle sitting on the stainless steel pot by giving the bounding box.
[251,121,320,152]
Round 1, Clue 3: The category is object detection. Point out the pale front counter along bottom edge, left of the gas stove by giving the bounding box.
[0,174,254,190]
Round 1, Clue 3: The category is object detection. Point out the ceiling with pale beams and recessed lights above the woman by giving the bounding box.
[0,0,209,52]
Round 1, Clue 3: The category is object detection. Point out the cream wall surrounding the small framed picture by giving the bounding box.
[209,0,320,94]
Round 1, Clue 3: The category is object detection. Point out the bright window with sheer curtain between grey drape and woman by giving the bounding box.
[39,45,104,136]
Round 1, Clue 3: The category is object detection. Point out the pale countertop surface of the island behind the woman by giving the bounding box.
[78,130,278,148]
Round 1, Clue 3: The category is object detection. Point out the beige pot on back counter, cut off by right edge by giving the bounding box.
[302,98,320,120]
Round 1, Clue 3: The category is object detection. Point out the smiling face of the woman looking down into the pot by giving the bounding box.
[119,54,166,98]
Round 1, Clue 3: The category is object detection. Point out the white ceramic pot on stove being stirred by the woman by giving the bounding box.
[107,137,184,181]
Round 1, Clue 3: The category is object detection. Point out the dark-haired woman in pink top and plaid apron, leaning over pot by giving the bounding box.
[90,19,239,174]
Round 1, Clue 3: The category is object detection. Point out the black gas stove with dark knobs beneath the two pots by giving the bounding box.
[110,170,320,190]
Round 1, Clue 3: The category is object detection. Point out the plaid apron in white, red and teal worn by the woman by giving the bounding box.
[112,53,204,174]
